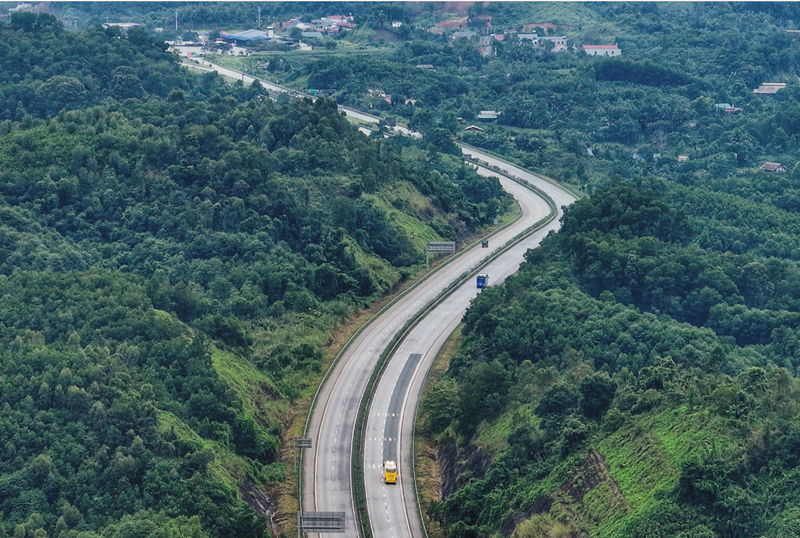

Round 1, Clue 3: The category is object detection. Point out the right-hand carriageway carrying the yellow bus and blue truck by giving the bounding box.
[364,154,575,538]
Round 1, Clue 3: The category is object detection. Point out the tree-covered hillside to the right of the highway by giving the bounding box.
[423,180,800,537]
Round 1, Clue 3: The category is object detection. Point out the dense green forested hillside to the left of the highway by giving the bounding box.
[0,12,511,538]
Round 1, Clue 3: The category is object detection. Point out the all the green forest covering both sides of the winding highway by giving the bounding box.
[10,2,800,538]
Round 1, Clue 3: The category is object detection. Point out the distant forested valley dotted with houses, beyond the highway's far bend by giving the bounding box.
[230,2,800,197]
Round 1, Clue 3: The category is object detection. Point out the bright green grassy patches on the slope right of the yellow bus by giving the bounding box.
[462,404,741,538]
